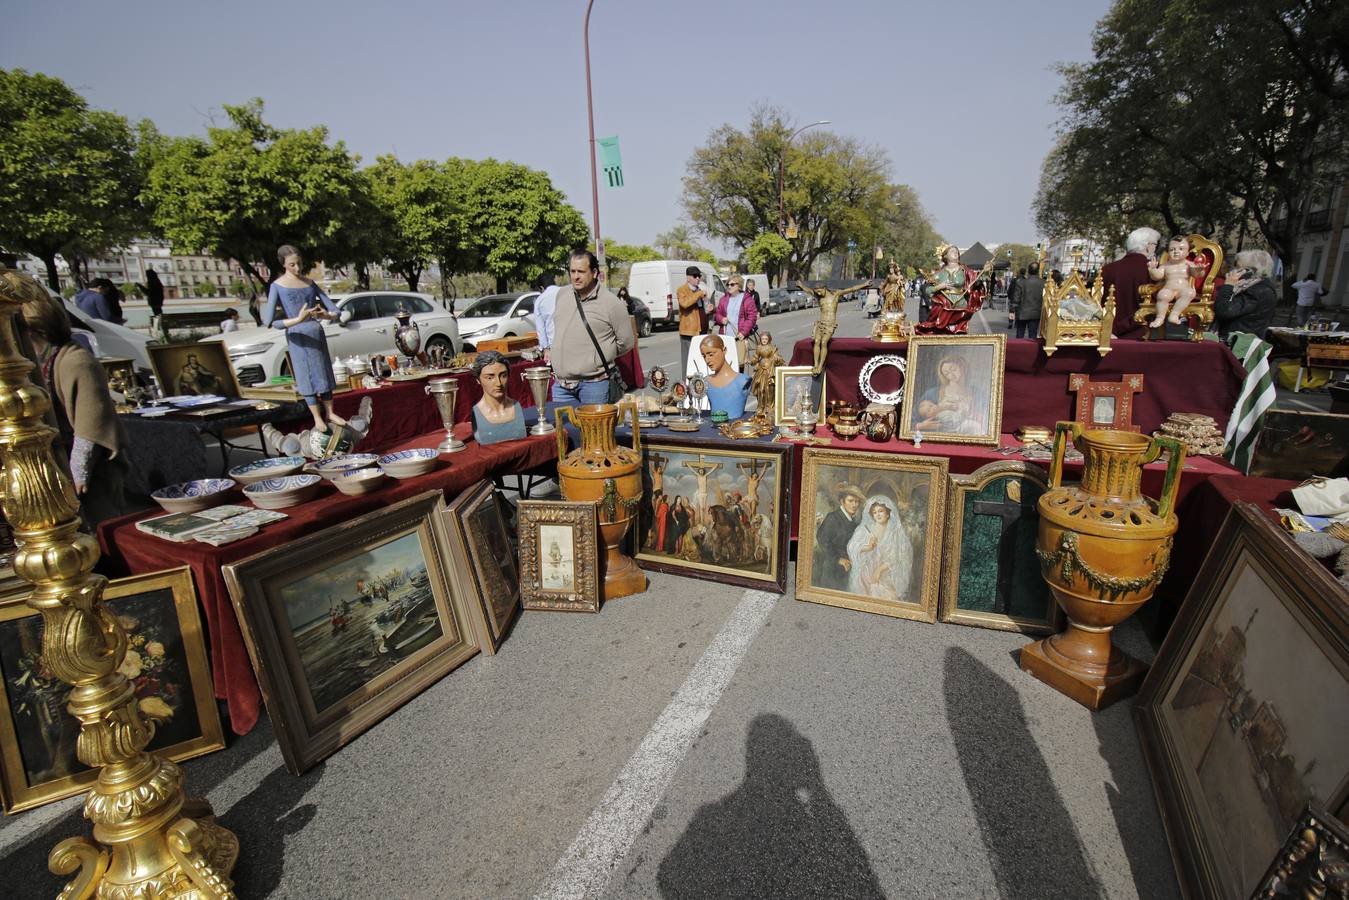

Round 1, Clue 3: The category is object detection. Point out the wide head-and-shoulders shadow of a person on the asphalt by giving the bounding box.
[657,715,885,900]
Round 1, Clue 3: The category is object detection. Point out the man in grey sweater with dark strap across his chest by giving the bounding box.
[552,250,637,403]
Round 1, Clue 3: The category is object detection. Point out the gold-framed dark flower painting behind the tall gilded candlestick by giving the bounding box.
[0,567,225,812]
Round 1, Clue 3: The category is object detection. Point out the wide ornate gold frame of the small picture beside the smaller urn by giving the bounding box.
[515,501,603,613]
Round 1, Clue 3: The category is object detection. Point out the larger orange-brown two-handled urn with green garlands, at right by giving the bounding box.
[1021,422,1184,710]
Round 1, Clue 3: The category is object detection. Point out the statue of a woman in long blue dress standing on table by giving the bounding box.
[262,244,347,434]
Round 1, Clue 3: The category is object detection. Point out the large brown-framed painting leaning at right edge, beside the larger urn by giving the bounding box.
[1135,503,1349,900]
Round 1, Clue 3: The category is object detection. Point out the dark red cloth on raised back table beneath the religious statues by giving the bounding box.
[792,337,1246,434]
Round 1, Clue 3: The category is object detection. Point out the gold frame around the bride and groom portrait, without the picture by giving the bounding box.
[796,447,950,622]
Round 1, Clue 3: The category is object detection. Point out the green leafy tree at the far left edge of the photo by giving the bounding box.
[0,69,144,290]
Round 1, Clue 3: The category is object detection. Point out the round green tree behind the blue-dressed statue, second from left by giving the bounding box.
[142,100,363,283]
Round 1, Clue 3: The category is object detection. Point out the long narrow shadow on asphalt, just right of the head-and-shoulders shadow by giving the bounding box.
[943,648,1102,900]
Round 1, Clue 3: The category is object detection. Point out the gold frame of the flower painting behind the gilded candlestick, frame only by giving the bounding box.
[0,565,225,814]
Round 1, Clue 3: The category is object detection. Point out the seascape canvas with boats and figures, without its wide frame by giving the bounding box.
[281,532,452,714]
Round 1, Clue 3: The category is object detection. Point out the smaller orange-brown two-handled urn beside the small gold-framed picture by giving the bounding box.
[554,402,646,600]
